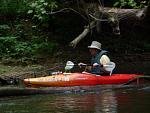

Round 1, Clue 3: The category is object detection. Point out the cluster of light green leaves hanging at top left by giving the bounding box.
[27,0,58,22]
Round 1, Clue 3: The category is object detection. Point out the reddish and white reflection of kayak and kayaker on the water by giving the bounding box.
[54,91,117,113]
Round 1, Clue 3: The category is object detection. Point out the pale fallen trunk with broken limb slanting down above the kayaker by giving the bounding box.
[70,6,150,48]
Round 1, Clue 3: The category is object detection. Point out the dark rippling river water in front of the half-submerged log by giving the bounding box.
[0,86,150,113]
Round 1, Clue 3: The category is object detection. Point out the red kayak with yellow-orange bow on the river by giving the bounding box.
[24,72,143,87]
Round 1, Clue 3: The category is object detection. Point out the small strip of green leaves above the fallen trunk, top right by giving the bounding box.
[113,0,146,8]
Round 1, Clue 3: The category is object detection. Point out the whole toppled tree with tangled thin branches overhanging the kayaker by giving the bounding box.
[51,0,150,47]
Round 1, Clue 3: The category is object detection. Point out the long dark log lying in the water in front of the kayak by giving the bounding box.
[0,83,149,97]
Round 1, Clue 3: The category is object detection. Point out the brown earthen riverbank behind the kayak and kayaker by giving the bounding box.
[0,51,150,84]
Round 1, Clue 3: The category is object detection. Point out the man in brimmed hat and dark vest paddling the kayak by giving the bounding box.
[78,41,110,75]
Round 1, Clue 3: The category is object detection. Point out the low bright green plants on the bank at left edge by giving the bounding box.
[0,37,57,59]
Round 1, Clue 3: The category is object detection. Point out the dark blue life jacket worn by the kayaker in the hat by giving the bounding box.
[91,50,108,74]
